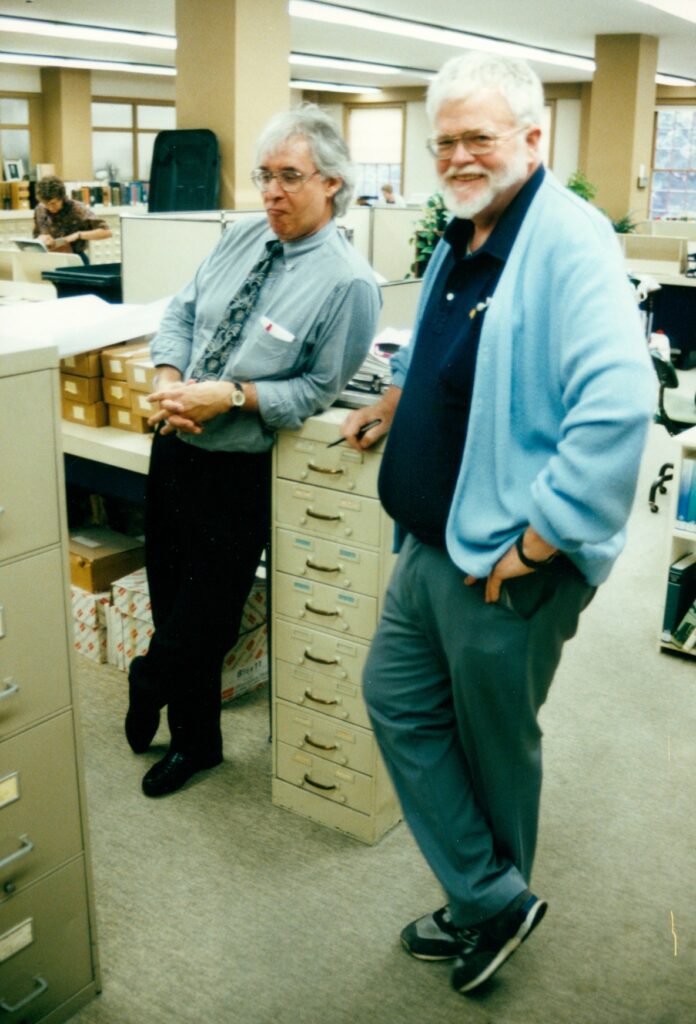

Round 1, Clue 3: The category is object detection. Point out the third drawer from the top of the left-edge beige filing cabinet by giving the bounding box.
[0,712,82,901]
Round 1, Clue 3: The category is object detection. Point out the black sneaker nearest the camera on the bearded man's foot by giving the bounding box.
[452,889,548,992]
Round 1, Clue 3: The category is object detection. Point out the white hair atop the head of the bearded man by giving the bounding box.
[426,50,543,125]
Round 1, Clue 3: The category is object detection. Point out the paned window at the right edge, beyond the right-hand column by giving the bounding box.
[650,105,696,219]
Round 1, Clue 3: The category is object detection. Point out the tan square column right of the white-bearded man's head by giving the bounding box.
[586,35,658,220]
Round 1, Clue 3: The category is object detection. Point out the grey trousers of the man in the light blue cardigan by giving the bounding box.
[364,536,595,927]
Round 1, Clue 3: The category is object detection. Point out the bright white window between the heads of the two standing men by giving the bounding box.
[348,105,403,199]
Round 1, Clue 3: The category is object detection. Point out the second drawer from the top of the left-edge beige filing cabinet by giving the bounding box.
[0,548,70,738]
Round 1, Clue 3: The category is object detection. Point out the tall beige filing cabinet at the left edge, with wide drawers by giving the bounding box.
[0,343,99,1024]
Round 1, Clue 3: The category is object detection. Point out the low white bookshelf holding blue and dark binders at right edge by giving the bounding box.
[659,427,696,657]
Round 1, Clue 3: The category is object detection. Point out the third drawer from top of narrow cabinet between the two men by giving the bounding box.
[275,529,380,597]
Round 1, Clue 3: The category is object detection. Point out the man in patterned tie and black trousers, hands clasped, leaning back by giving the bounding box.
[125,104,381,797]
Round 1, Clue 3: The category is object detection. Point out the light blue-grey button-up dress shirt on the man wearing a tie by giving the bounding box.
[150,216,381,452]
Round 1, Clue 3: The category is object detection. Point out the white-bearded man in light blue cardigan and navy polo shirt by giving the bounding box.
[342,53,655,992]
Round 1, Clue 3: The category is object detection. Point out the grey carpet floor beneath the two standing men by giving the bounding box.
[69,427,696,1024]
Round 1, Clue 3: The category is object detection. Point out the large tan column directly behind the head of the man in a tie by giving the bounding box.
[176,0,291,210]
